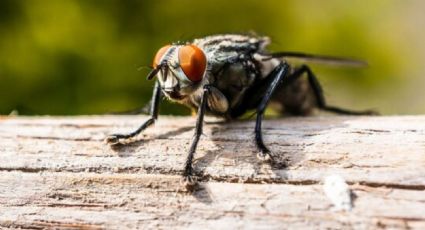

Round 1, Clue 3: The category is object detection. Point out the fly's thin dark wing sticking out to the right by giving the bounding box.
[265,52,368,68]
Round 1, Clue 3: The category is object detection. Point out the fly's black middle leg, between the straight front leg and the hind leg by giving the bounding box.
[255,63,289,161]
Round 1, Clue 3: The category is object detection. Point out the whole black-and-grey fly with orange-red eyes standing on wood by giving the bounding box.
[106,34,373,185]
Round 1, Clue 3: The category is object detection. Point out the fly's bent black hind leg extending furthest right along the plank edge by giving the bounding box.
[288,65,378,115]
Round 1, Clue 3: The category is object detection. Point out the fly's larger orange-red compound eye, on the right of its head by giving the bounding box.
[179,45,207,82]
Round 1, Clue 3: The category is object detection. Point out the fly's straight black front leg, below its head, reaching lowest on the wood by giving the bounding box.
[183,85,210,186]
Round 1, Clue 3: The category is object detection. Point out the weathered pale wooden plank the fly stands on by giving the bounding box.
[0,116,425,229]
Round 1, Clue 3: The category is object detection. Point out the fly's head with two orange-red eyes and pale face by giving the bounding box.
[148,44,207,101]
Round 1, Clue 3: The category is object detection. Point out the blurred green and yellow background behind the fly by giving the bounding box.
[0,0,425,115]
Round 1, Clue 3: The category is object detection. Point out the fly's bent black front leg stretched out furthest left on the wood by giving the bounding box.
[106,82,161,145]
